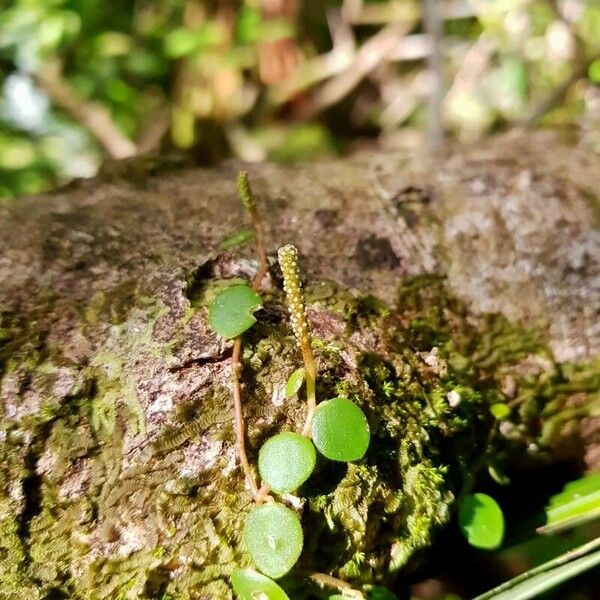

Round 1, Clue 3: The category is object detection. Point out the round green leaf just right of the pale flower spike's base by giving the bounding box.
[312,398,371,462]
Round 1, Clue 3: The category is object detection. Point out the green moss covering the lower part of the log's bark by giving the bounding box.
[0,277,600,600]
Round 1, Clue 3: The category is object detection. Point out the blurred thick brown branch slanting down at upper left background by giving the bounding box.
[36,62,137,159]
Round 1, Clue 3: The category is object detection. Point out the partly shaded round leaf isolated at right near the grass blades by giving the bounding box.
[458,494,504,550]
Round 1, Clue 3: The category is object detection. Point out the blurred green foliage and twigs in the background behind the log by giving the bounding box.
[0,0,600,197]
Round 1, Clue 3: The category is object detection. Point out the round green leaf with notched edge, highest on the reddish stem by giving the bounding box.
[208,284,262,339]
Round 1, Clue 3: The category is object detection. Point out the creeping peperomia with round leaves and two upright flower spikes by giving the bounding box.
[209,173,370,600]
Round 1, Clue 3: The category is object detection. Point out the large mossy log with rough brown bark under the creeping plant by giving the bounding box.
[0,134,600,600]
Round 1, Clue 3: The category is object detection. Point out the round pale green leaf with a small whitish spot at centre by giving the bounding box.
[243,502,304,579]
